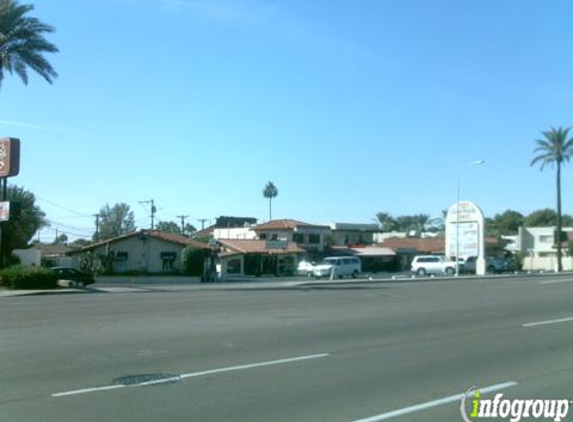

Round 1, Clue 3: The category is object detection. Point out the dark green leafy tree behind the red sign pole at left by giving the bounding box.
[2,185,48,256]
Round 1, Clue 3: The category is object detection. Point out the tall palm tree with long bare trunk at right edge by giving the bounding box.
[531,127,573,272]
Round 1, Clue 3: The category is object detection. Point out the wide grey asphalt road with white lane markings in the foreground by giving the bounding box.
[0,275,573,422]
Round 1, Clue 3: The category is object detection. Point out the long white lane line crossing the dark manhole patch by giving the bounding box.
[52,353,330,397]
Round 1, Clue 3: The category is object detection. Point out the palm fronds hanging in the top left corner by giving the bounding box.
[0,0,58,85]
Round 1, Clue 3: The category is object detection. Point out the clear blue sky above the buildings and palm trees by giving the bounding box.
[0,0,573,240]
